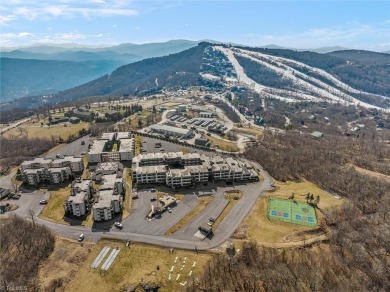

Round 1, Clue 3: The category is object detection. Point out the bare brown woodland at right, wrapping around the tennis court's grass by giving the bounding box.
[187,132,390,291]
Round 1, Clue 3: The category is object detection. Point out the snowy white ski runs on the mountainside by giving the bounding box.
[214,46,390,112]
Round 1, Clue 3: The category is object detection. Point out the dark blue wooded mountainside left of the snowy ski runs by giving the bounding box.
[58,43,208,100]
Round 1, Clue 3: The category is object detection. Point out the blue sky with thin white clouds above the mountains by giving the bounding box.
[0,0,390,51]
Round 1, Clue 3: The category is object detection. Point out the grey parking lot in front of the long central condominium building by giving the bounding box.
[116,178,259,240]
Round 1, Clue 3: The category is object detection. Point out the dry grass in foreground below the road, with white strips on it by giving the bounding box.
[65,240,210,292]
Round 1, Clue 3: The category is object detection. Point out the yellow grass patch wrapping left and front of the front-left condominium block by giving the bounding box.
[39,184,93,227]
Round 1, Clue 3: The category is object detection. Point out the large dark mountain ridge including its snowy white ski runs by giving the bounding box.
[1,42,390,112]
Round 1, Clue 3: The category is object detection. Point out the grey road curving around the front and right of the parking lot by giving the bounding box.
[30,162,273,250]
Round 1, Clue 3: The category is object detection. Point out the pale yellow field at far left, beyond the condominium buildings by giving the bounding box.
[4,122,89,139]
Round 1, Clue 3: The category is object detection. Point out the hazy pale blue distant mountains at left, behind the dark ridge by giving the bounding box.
[0,40,198,102]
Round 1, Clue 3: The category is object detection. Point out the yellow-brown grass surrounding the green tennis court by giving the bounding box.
[235,181,343,243]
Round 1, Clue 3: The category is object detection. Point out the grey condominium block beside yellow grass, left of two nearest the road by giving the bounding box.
[64,180,92,217]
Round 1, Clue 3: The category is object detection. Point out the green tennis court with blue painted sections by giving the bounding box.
[268,197,317,226]
